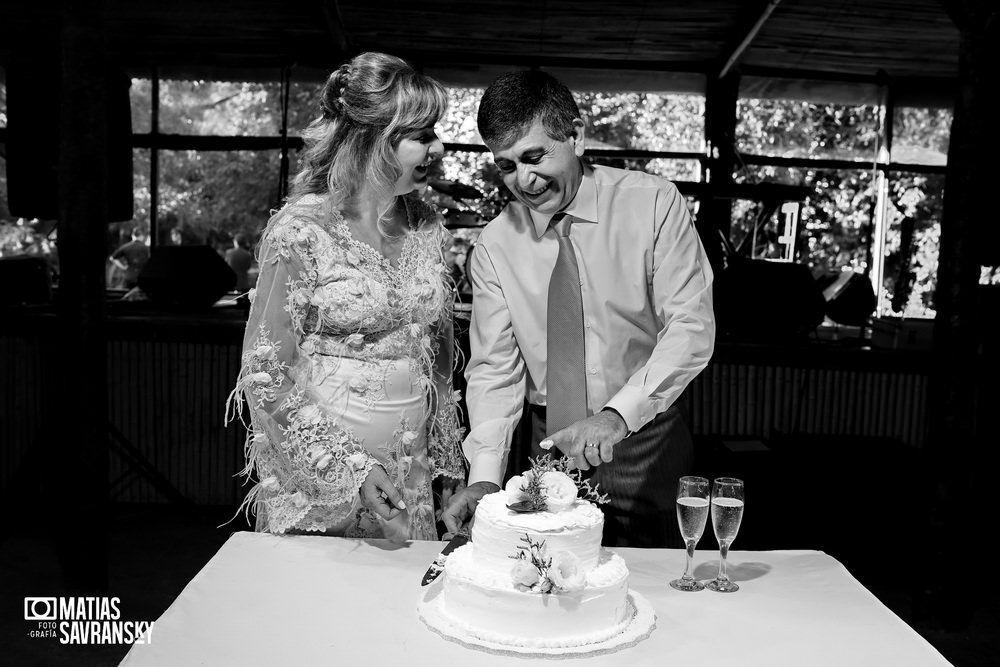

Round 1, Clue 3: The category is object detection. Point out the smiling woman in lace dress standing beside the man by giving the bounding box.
[227,53,465,539]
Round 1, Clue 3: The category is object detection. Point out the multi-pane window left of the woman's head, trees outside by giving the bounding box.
[121,79,300,288]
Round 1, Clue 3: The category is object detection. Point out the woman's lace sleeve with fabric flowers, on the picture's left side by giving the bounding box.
[227,213,376,533]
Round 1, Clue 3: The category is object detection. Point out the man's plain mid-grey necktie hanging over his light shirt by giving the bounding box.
[545,213,587,434]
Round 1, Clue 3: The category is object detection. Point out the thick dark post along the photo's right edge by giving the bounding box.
[928,0,1000,630]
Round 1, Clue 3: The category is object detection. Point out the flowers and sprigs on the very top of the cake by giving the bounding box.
[504,454,608,512]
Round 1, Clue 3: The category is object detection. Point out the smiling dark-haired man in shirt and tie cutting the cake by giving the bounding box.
[442,71,715,547]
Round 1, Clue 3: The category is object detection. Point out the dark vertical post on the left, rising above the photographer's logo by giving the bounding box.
[49,0,109,594]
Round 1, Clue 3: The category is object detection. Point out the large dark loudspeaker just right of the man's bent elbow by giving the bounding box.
[715,259,826,342]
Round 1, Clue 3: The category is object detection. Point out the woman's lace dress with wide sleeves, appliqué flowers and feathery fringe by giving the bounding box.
[227,195,465,539]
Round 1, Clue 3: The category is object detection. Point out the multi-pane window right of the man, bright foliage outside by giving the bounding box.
[733,94,951,317]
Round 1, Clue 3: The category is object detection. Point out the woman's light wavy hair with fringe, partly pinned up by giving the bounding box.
[289,52,448,205]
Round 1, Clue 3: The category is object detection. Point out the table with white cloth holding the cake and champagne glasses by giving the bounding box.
[121,532,949,667]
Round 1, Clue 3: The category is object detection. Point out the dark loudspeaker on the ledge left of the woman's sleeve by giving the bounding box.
[139,245,236,308]
